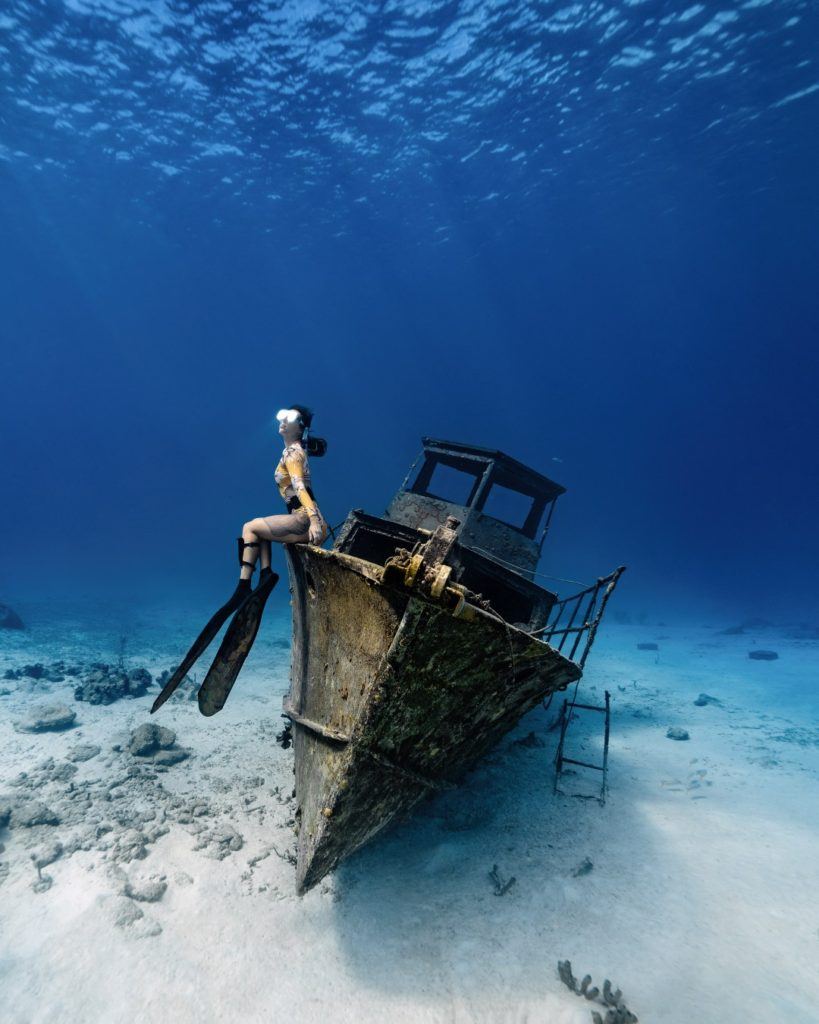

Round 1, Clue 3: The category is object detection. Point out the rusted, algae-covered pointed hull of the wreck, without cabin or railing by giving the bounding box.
[285,545,581,892]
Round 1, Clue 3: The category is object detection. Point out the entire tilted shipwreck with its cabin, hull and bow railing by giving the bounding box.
[284,437,624,893]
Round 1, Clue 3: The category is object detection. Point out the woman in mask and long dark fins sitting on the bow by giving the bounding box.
[150,406,328,715]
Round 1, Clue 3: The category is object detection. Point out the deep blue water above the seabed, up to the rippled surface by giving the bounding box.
[0,0,819,623]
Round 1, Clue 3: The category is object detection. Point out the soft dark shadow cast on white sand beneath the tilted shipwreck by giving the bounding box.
[325,700,696,1019]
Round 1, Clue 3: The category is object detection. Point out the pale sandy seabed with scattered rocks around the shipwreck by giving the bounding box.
[0,604,819,1024]
